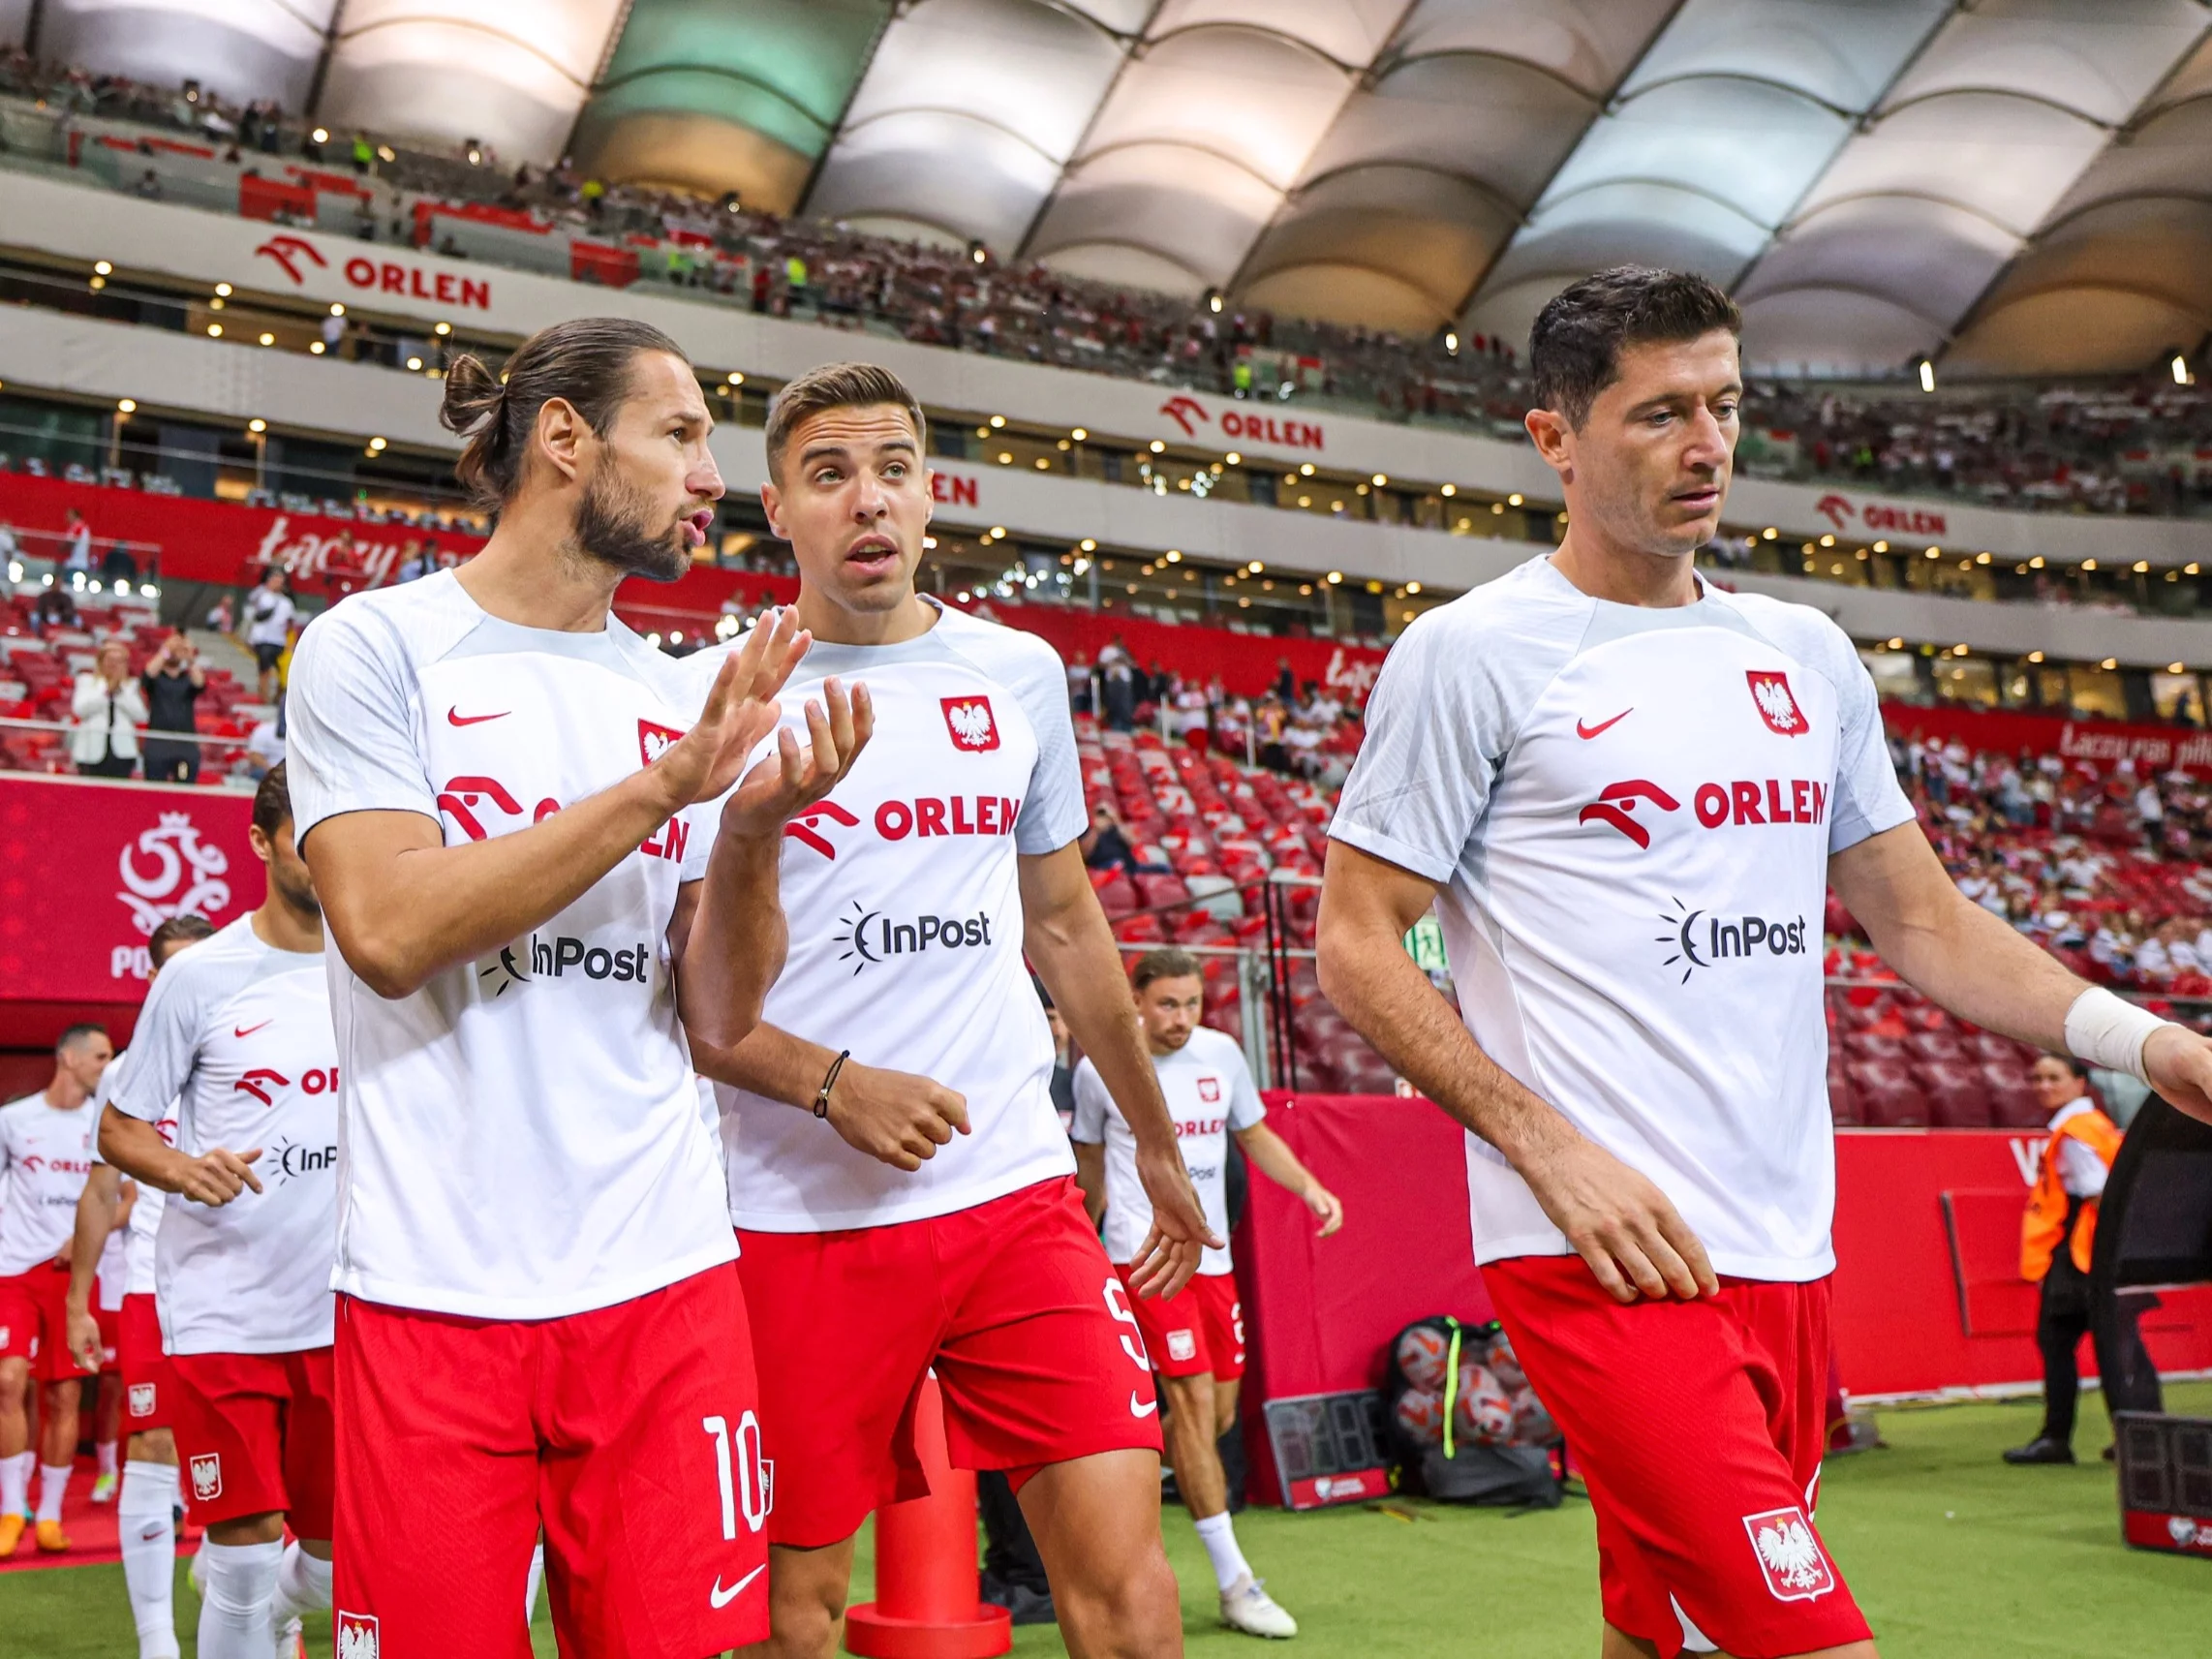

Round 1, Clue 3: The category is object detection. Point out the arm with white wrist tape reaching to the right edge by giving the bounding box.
[1828,823,2212,1121]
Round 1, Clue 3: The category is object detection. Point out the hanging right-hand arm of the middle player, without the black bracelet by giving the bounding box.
[1020,841,1221,1296]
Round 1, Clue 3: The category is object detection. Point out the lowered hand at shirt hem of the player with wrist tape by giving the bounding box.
[1520,1135,1721,1303]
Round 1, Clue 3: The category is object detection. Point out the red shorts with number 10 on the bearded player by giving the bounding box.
[329,1265,774,1659]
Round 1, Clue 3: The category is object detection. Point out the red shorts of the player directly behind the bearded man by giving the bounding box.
[169,1344,334,1540]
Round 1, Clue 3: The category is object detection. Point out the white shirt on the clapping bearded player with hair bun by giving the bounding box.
[290,570,737,1318]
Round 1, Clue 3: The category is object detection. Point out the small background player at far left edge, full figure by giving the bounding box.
[0,1024,115,1557]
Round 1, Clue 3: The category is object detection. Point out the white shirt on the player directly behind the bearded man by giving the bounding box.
[115,913,338,1354]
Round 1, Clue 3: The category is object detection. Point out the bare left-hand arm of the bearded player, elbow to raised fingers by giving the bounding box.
[301,610,808,998]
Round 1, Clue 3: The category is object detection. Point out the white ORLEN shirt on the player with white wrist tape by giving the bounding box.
[1330,558,1914,1280]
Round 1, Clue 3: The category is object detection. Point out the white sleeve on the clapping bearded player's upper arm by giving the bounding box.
[286,604,438,841]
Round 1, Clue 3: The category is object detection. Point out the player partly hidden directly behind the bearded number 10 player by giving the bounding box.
[100,765,338,1659]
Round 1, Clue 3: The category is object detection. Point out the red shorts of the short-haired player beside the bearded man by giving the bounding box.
[737,1177,1159,1549]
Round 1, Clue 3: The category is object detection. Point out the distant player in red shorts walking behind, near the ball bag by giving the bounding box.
[1073,949,1345,1637]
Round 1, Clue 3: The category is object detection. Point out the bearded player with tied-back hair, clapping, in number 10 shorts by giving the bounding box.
[290,319,870,1659]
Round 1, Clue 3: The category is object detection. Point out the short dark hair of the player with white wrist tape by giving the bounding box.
[1528,265,1743,431]
